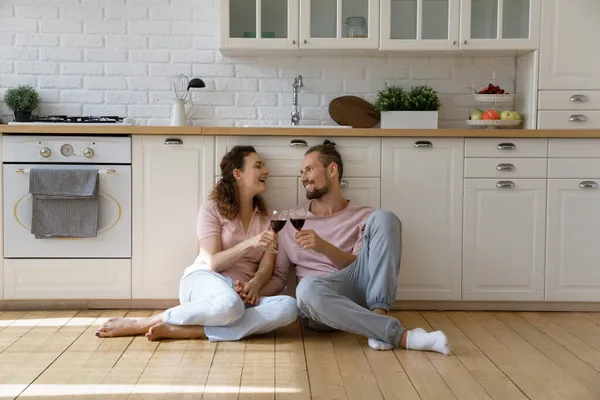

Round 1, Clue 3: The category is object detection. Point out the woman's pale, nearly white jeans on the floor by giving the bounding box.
[163,270,298,341]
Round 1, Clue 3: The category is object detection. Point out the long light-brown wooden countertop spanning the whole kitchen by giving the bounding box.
[0,125,600,138]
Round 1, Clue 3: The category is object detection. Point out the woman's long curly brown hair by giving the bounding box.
[208,146,267,219]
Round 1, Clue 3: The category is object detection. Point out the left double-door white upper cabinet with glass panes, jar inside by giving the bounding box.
[220,0,379,51]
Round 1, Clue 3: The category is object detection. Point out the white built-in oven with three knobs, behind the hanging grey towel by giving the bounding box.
[2,135,131,259]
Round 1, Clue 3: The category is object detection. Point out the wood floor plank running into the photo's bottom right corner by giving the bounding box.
[496,313,600,398]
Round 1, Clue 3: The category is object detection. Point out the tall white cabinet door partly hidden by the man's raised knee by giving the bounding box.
[381,138,464,300]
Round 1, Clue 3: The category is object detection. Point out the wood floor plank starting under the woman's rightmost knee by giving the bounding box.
[275,320,310,400]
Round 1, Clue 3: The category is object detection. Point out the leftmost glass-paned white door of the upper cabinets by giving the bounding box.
[219,0,298,51]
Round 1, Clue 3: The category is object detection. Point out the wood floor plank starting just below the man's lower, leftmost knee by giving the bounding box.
[302,329,348,400]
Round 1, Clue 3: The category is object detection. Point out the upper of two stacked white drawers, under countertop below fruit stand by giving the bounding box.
[465,138,548,158]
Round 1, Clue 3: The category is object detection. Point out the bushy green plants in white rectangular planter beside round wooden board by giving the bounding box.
[374,85,442,129]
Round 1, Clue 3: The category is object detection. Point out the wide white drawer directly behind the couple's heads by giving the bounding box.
[215,136,381,177]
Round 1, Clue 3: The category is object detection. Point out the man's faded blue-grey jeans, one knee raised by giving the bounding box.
[296,210,406,346]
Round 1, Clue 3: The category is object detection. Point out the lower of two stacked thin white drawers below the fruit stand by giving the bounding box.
[465,158,548,179]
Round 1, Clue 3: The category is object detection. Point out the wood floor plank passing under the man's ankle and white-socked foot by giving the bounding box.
[390,311,456,400]
